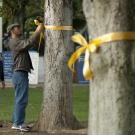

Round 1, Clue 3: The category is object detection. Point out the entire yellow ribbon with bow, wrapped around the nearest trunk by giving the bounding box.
[68,32,135,80]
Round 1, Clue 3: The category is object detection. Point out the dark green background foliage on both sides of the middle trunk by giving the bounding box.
[0,0,85,32]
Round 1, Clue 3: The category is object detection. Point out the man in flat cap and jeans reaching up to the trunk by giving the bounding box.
[7,23,44,132]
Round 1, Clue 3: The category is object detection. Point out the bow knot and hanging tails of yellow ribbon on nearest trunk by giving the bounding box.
[68,34,98,80]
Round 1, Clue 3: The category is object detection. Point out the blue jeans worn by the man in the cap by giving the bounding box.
[12,71,29,125]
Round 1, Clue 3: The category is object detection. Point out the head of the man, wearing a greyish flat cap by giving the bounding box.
[7,23,22,37]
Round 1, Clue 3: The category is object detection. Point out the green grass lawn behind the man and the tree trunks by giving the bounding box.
[0,85,89,122]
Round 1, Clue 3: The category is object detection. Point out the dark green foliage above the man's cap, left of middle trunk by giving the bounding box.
[1,0,44,31]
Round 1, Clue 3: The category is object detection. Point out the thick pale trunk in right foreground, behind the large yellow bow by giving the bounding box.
[83,0,135,135]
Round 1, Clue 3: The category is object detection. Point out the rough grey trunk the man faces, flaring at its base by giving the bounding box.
[38,0,79,132]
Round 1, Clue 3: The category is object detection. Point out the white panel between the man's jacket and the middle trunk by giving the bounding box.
[29,51,39,84]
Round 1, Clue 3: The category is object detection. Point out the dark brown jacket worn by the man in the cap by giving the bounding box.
[8,33,39,72]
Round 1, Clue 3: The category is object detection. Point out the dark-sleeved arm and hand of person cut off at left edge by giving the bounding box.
[0,54,5,89]
